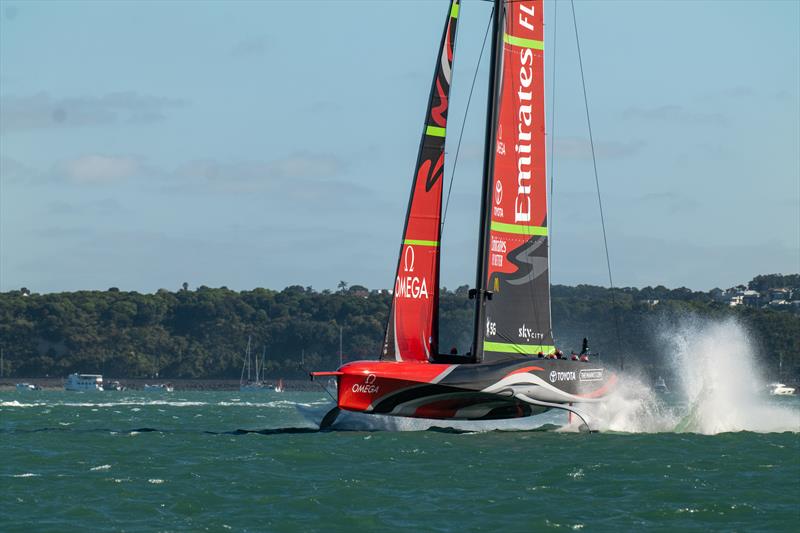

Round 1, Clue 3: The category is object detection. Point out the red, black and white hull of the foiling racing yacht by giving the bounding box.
[315,358,616,420]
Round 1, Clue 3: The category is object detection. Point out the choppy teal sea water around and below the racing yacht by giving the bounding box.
[0,391,800,532]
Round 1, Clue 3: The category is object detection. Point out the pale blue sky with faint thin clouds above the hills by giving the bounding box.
[0,0,800,292]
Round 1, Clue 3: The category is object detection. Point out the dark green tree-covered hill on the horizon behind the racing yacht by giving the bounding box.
[0,276,800,381]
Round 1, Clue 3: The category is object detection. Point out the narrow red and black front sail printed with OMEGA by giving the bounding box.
[381,0,459,362]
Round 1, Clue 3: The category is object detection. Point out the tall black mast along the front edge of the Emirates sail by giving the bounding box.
[470,0,503,362]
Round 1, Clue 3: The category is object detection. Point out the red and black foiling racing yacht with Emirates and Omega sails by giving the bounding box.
[312,0,617,427]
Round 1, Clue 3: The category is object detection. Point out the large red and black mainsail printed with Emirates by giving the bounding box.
[481,0,553,361]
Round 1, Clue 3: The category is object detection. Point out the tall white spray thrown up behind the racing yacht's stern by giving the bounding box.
[586,317,800,435]
